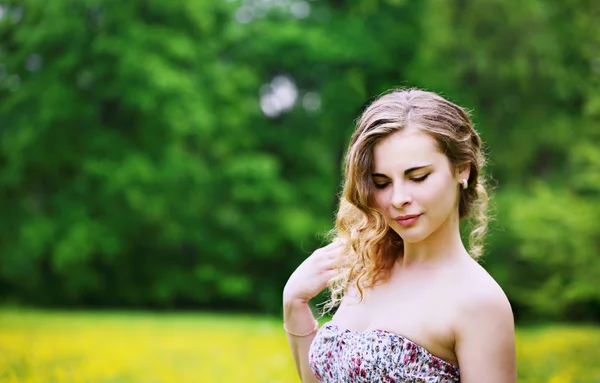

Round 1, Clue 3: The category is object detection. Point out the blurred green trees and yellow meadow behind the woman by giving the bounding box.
[0,0,600,383]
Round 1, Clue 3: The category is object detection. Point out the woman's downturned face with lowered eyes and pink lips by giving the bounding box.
[372,129,469,243]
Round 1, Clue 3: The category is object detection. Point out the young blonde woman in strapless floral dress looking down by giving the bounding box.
[283,89,516,383]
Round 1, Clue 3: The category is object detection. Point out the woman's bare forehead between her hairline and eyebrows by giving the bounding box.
[373,129,448,173]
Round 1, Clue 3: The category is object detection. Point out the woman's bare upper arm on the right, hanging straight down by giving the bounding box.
[455,290,517,383]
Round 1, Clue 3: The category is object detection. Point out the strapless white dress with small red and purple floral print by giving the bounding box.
[309,323,460,383]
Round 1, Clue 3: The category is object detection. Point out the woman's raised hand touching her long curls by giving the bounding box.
[283,241,344,303]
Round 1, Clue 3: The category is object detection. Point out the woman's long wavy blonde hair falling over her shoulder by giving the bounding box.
[324,89,488,312]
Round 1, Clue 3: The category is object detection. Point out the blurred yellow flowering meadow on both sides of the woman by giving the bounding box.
[0,309,600,383]
